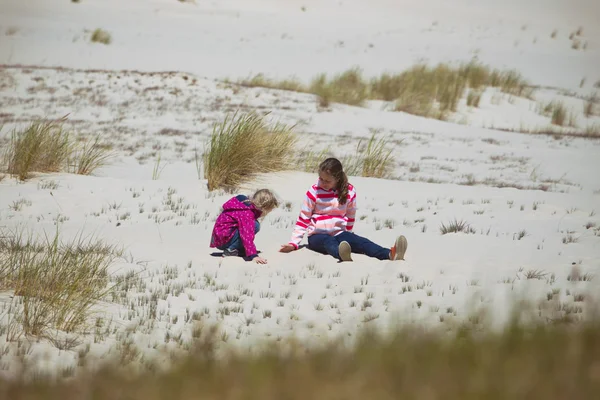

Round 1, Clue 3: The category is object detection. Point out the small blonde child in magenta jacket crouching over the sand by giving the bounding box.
[210,189,279,264]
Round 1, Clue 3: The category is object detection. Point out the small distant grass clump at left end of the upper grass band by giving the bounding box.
[308,68,369,107]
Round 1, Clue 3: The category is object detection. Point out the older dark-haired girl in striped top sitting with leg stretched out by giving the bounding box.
[279,158,407,261]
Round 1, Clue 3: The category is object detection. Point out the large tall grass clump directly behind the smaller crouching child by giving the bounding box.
[203,112,297,191]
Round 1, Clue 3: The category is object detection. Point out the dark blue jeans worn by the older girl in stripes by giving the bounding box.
[308,232,390,260]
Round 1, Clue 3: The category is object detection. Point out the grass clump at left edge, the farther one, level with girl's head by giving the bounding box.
[3,118,115,180]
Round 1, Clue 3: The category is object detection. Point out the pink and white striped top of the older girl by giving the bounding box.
[289,183,356,249]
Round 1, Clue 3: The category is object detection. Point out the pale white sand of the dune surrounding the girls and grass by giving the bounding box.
[0,0,600,380]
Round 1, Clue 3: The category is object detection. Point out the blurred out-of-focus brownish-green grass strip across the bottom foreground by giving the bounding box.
[0,310,600,400]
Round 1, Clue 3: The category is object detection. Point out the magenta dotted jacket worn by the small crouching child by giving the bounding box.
[210,195,262,257]
